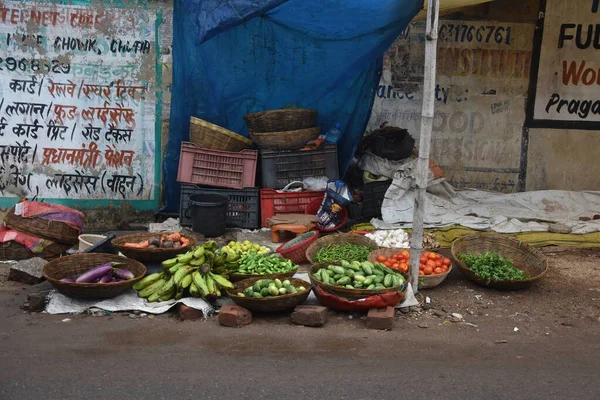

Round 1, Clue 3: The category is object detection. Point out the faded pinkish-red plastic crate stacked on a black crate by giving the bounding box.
[177,142,258,189]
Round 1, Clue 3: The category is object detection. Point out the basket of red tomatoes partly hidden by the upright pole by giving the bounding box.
[369,249,452,289]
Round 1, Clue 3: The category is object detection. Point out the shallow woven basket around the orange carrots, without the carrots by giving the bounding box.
[112,232,196,263]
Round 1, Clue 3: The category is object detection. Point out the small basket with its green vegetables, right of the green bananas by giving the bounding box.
[227,278,311,312]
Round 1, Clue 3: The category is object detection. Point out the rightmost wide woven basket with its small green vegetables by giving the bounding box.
[452,233,548,290]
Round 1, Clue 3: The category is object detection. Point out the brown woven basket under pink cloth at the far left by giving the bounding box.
[4,207,80,246]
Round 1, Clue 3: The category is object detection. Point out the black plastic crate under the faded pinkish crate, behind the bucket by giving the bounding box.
[179,184,260,229]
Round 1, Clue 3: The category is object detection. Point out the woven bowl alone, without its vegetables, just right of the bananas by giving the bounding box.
[227,277,311,312]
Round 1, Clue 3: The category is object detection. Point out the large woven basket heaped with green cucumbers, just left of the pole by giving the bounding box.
[309,261,406,299]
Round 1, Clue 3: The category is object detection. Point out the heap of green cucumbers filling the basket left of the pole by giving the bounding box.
[312,261,406,290]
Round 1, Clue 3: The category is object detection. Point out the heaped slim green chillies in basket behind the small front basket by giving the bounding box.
[229,253,298,282]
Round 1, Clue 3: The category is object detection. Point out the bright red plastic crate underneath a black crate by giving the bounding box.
[260,189,325,228]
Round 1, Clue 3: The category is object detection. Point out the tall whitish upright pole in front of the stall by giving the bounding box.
[410,0,440,293]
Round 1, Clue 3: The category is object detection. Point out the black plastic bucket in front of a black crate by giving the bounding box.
[189,193,229,237]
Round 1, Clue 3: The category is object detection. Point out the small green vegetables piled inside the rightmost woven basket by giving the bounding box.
[458,252,530,283]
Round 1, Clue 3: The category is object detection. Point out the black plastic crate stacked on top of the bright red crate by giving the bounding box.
[260,144,340,189]
